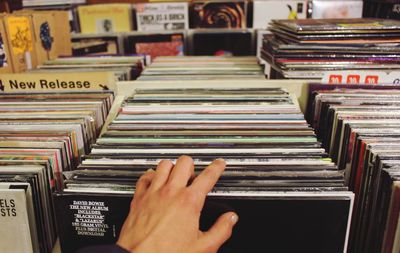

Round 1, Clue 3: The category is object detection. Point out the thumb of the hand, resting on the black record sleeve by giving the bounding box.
[202,212,239,252]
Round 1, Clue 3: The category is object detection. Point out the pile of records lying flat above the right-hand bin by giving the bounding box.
[261,19,400,79]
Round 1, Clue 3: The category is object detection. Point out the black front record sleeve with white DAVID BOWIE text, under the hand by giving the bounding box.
[56,192,352,252]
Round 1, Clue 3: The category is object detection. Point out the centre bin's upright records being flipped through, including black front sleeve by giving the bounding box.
[56,88,353,253]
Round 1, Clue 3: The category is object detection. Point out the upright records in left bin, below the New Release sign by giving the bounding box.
[0,92,113,253]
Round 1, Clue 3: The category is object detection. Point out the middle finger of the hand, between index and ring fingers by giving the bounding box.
[168,155,194,188]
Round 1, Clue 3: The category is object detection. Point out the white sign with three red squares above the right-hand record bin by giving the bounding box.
[322,71,400,85]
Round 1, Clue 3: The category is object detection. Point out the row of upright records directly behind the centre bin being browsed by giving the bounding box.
[138,56,265,80]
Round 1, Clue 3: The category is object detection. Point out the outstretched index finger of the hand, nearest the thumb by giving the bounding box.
[190,158,226,196]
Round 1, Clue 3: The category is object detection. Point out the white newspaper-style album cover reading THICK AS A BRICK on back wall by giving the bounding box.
[135,2,189,31]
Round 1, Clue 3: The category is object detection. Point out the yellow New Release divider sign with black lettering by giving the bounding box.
[0,72,116,92]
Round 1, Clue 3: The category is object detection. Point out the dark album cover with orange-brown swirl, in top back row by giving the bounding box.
[190,1,247,28]
